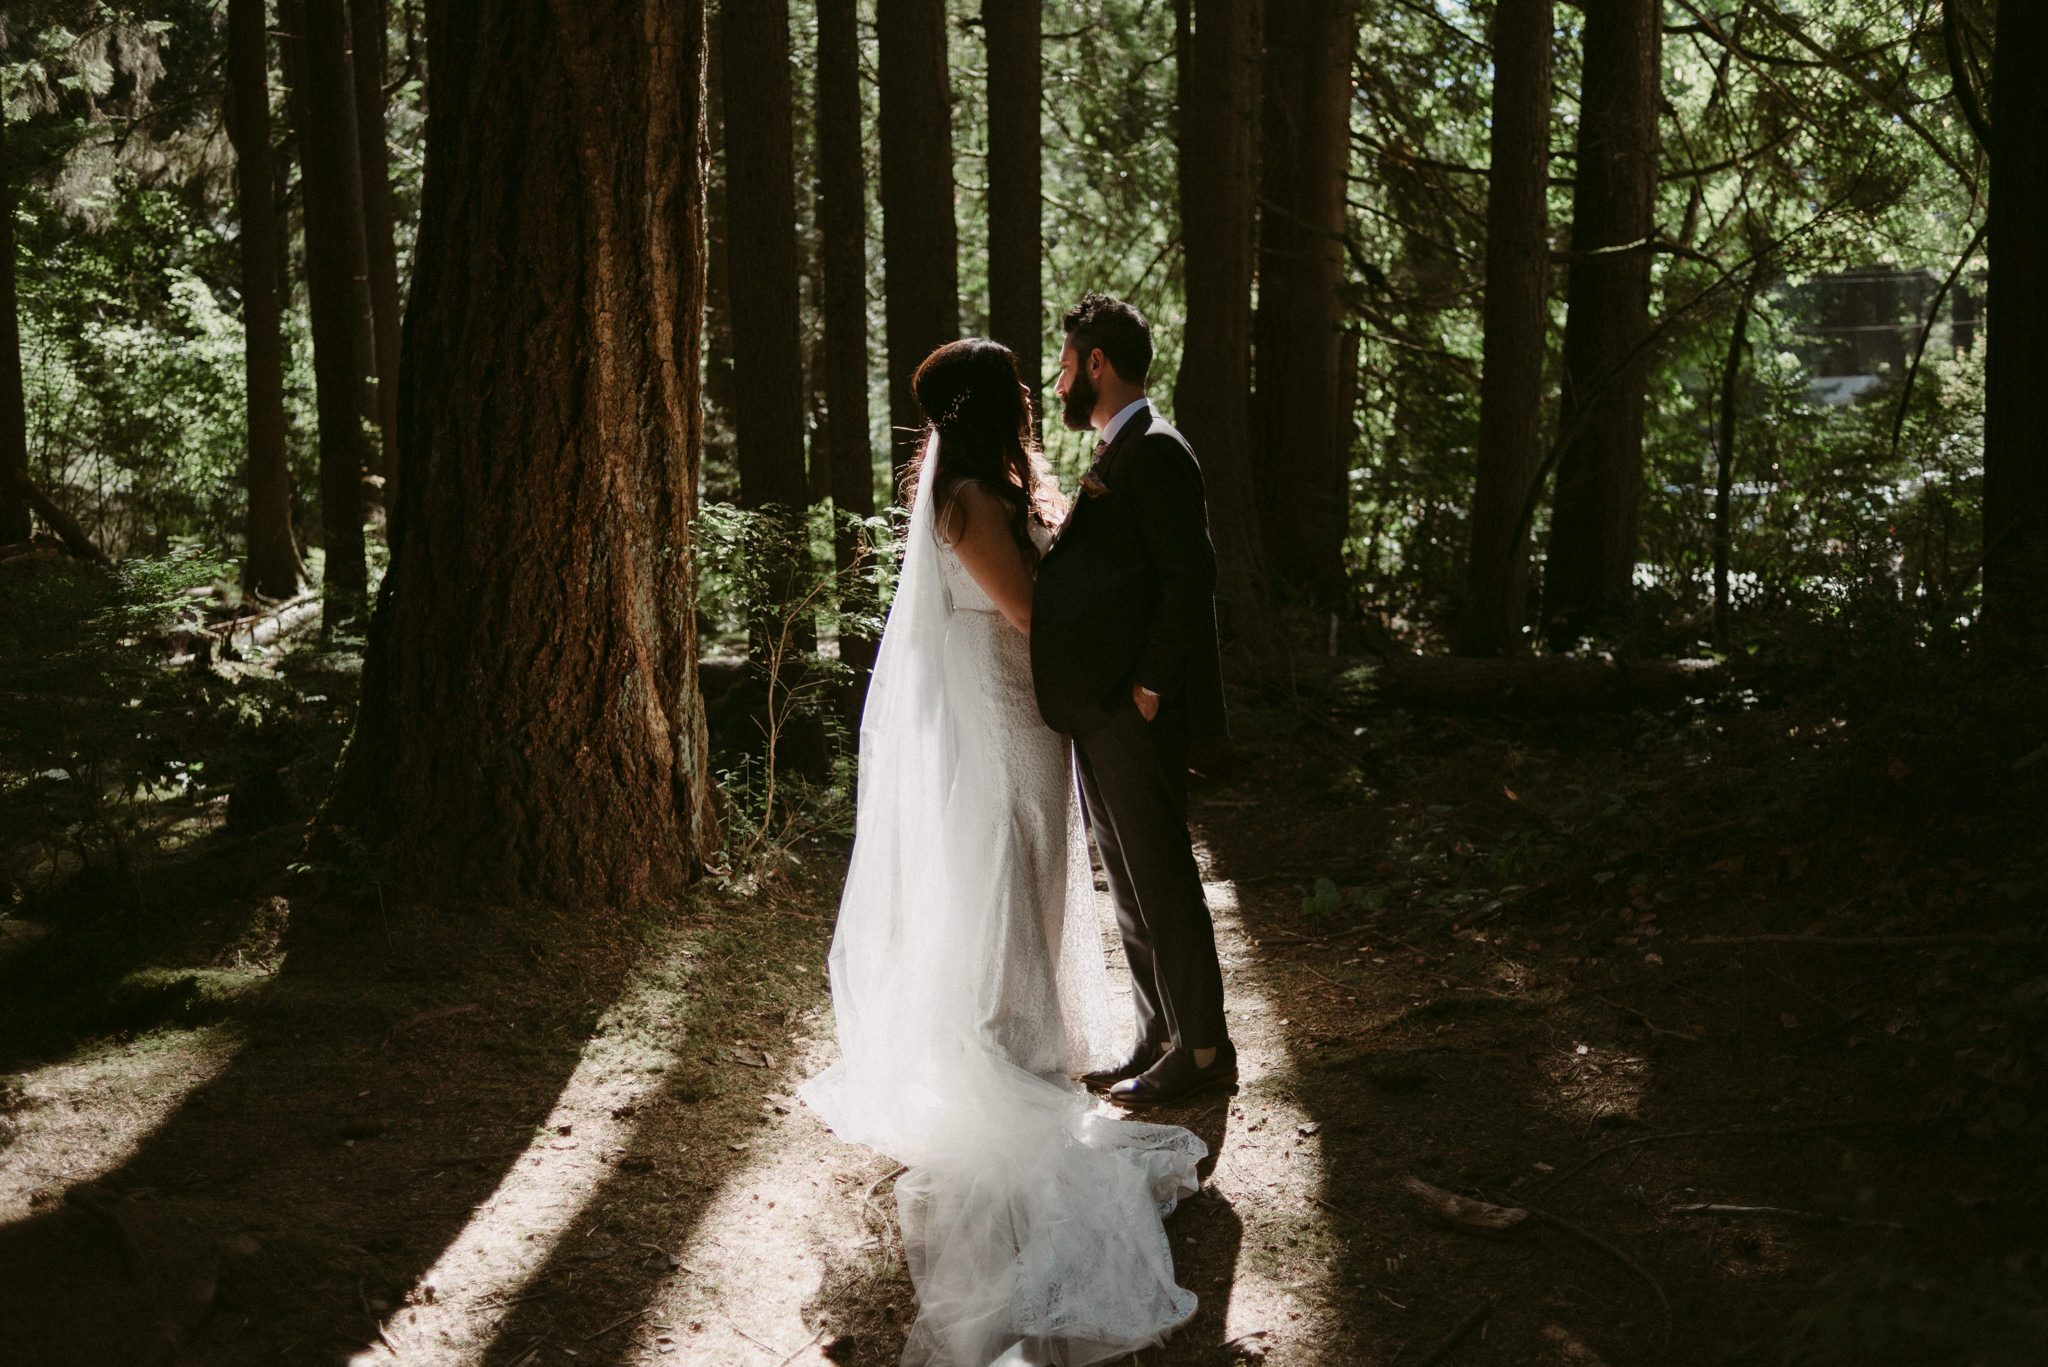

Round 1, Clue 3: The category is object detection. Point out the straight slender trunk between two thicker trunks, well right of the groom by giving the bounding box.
[1458,0,1552,656]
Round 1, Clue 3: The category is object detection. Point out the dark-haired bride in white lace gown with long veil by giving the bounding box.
[799,338,1206,1367]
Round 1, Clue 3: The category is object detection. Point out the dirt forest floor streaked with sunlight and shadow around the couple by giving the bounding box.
[0,610,2048,1367]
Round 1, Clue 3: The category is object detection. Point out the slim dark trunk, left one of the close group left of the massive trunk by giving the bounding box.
[227,0,301,598]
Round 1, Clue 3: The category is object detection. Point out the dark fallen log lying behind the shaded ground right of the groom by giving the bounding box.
[1372,656,1729,711]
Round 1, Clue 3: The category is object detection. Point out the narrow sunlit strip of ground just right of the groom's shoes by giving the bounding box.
[1196,860,1343,1361]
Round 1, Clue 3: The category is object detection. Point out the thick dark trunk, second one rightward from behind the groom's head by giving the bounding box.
[1253,0,1358,611]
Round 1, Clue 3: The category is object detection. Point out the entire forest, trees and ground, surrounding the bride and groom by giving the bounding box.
[0,0,2048,1367]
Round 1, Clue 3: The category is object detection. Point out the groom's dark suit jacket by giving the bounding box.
[1030,408,1225,736]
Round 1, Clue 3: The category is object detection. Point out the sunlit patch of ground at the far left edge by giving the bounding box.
[0,1025,244,1224]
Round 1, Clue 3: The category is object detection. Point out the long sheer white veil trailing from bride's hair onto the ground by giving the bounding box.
[799,439,1206,1367]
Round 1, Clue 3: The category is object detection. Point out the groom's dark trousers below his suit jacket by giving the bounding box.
[1073,701,1229,1049]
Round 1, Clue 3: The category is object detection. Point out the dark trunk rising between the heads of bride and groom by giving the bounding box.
[981,0,1044,430]
